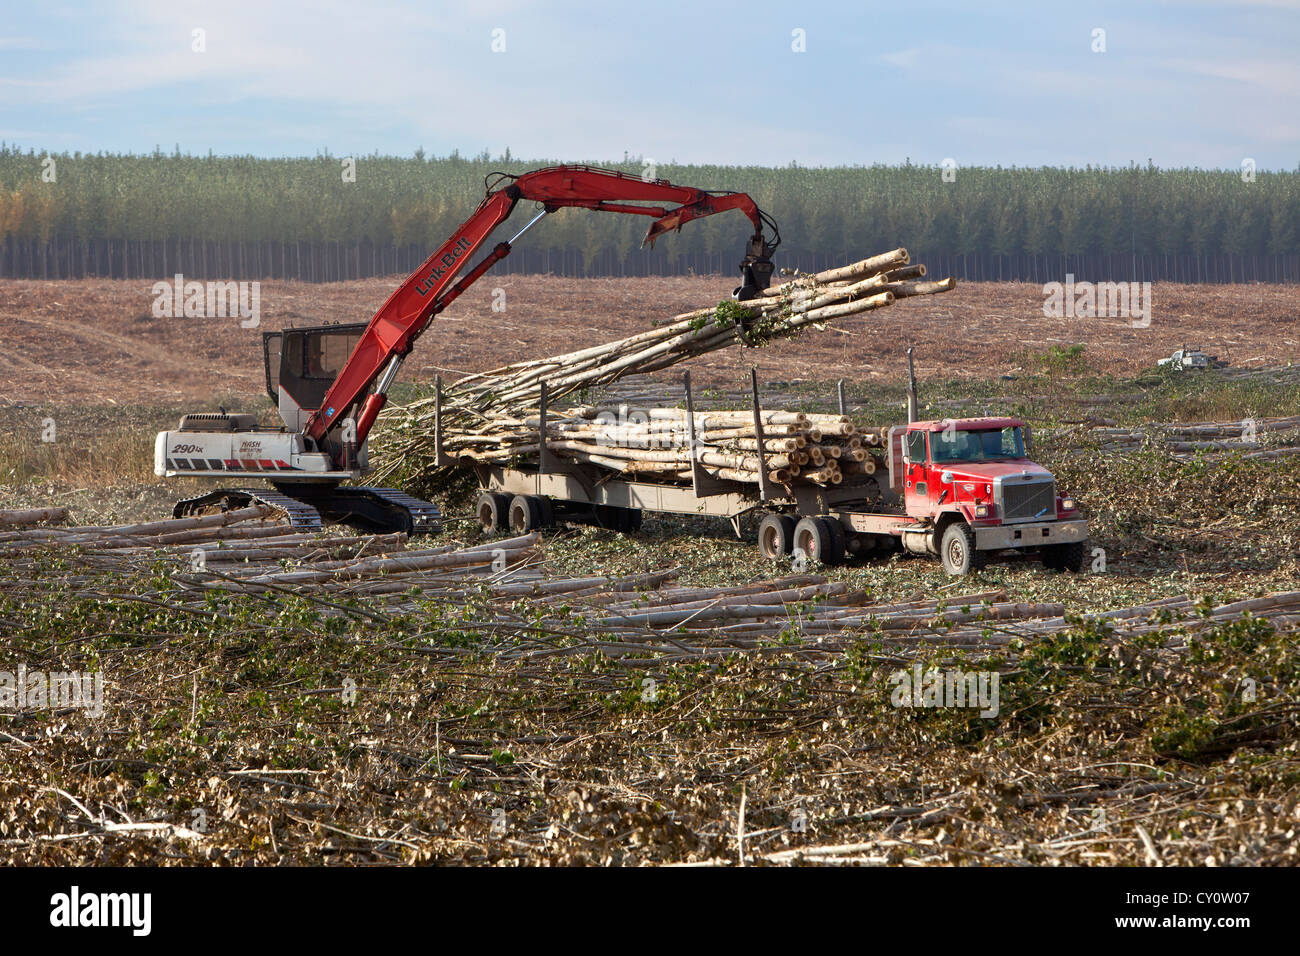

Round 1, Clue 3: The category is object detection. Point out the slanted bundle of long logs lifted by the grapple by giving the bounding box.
[374,248,956,483]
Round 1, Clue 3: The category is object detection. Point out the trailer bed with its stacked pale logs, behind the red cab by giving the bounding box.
[434,371,909,564]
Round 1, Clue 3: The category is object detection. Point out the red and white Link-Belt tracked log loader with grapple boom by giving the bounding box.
[153,165,780,533]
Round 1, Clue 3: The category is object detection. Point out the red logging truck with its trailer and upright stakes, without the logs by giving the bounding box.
[457,361,1088,575]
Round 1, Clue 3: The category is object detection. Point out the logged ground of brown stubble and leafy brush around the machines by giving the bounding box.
[0,278,1300,865]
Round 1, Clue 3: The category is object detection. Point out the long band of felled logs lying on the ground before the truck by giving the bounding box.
[0,506,1300,669]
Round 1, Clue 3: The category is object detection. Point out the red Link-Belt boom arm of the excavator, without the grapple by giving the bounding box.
[306,166,771,455]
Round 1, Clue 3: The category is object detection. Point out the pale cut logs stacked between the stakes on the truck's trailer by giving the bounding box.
[443,406,888,486]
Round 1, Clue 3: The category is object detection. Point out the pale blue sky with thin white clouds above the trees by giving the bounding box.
[0,0,1300,169]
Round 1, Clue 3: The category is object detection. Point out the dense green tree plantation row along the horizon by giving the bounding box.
[0,146,1300,281]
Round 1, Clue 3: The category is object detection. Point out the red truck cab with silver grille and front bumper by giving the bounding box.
[891,418,1088,574]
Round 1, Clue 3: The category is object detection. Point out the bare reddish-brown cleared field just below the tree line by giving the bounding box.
[0,276,1300,405]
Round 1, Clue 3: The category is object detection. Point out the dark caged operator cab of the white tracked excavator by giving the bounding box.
[261,323,368,432]
